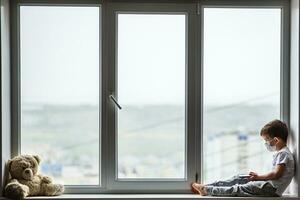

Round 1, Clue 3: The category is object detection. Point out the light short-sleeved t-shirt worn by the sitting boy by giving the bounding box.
[268,147,295,196]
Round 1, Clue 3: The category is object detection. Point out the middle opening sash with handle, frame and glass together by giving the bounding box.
[104,3,196,193]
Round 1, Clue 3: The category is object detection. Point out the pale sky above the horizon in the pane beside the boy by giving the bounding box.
[203,8,281,105]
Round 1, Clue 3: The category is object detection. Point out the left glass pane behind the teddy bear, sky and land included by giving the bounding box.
[20,6,100,185]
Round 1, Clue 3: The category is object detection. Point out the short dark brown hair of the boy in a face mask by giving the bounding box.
[260,119,289,143]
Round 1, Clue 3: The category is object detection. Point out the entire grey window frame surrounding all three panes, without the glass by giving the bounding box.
[10,0,290,194]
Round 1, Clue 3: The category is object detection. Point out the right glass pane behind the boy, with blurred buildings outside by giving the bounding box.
[203,8,281,183]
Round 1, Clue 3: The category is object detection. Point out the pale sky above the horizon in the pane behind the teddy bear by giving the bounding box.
[20,6,100,105]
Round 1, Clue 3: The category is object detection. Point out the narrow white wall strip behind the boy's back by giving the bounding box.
[290,0,300,196]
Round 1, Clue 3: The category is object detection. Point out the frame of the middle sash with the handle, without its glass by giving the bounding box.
[104,2,197,193]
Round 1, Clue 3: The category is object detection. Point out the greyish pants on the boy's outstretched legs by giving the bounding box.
[205,175,278,197]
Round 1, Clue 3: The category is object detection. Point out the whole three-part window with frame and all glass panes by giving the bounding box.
[12,0,289,193]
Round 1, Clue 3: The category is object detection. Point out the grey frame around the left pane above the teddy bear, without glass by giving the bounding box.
[11,0,104,193]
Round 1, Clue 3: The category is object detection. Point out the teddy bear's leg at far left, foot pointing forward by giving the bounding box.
[5,181,29,200]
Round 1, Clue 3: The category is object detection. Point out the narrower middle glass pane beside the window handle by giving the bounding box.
[117,14,186,178]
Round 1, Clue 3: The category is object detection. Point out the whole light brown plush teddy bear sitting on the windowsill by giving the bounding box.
[5,155,64,200]
